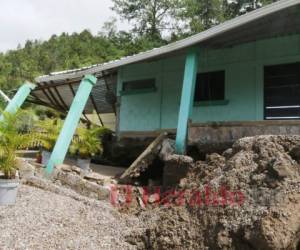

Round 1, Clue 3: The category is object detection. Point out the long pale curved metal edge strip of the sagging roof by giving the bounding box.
[36,0,300,82]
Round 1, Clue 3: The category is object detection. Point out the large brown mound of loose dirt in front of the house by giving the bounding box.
[128,136,300,250]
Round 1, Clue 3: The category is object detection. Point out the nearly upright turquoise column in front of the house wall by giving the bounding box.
[176,50,198,154]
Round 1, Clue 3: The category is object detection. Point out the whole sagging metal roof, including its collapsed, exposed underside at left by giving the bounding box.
[30,0,300,120]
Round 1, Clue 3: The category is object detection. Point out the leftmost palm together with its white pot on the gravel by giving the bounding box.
[0,111,35,205]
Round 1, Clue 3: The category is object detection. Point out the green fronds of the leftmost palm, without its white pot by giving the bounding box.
[0,110,36,179]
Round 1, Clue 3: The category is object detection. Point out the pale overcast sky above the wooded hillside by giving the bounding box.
[0,0,129,52]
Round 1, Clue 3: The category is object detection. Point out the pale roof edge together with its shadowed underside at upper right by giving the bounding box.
[36,0,300,82]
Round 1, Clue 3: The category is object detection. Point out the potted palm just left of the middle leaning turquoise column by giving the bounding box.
[35,118,63,166]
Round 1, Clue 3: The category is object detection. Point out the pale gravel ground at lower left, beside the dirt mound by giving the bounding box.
[0,185,138,250]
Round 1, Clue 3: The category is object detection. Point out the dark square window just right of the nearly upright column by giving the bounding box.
[195,71,225,102]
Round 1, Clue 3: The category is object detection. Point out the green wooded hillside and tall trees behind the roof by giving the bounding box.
[0,0,276,91]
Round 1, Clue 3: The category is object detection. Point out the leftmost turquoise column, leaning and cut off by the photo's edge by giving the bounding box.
[0,82,36,116]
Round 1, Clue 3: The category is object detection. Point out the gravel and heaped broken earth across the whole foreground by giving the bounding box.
[0,136,300,250]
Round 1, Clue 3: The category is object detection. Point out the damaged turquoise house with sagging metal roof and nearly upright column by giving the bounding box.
[24,0,300,174]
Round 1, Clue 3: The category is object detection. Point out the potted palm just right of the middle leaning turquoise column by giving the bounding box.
[70,126,108,171]
